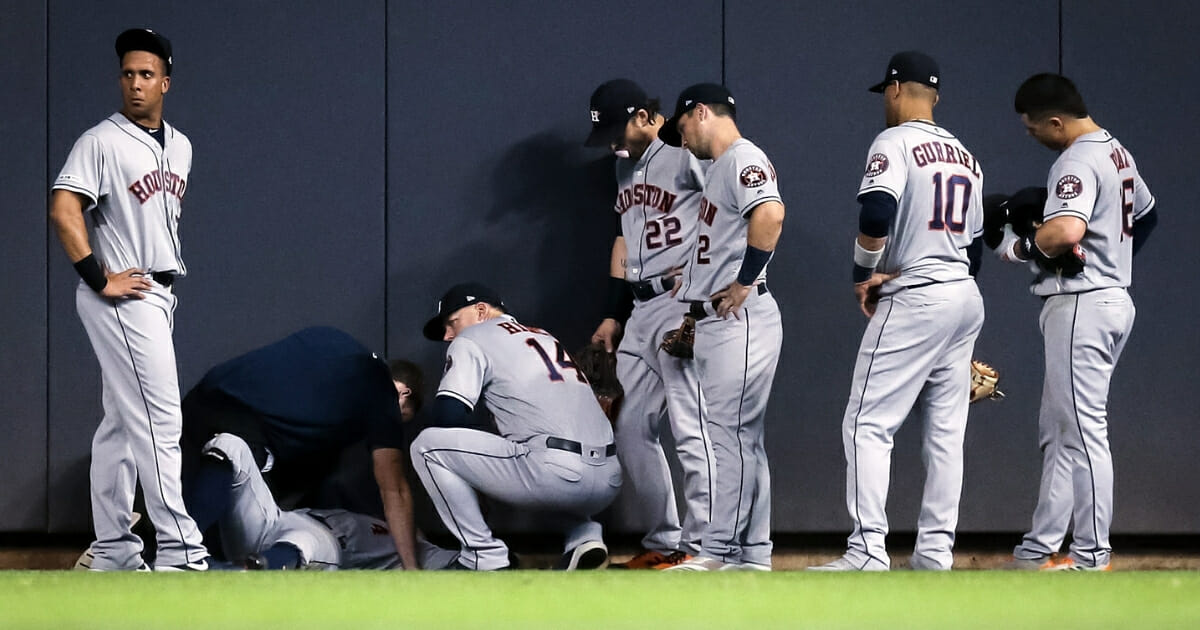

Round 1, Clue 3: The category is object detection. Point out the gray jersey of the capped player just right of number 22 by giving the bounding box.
[679,138,781,301]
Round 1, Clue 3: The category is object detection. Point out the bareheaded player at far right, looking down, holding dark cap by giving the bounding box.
[997,73,1158,571]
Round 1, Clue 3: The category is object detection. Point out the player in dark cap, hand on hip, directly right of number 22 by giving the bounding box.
[659,83,784,571]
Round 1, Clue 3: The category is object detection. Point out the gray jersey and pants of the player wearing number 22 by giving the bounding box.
[613,139,713,554]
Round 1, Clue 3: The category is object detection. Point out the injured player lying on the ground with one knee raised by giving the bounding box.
[204,433,458,570]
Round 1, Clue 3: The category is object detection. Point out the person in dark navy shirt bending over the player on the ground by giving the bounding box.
[177,326,420,569]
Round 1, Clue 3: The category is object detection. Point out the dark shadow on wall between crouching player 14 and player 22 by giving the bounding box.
[406,128,617,532]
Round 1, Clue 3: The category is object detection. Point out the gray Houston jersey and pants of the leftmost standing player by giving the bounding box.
[54,114,208,570]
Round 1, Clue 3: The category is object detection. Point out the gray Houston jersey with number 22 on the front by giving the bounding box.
[613,138,704,282]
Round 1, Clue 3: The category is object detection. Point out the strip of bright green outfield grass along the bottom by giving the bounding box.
[0,571,1200,630]
